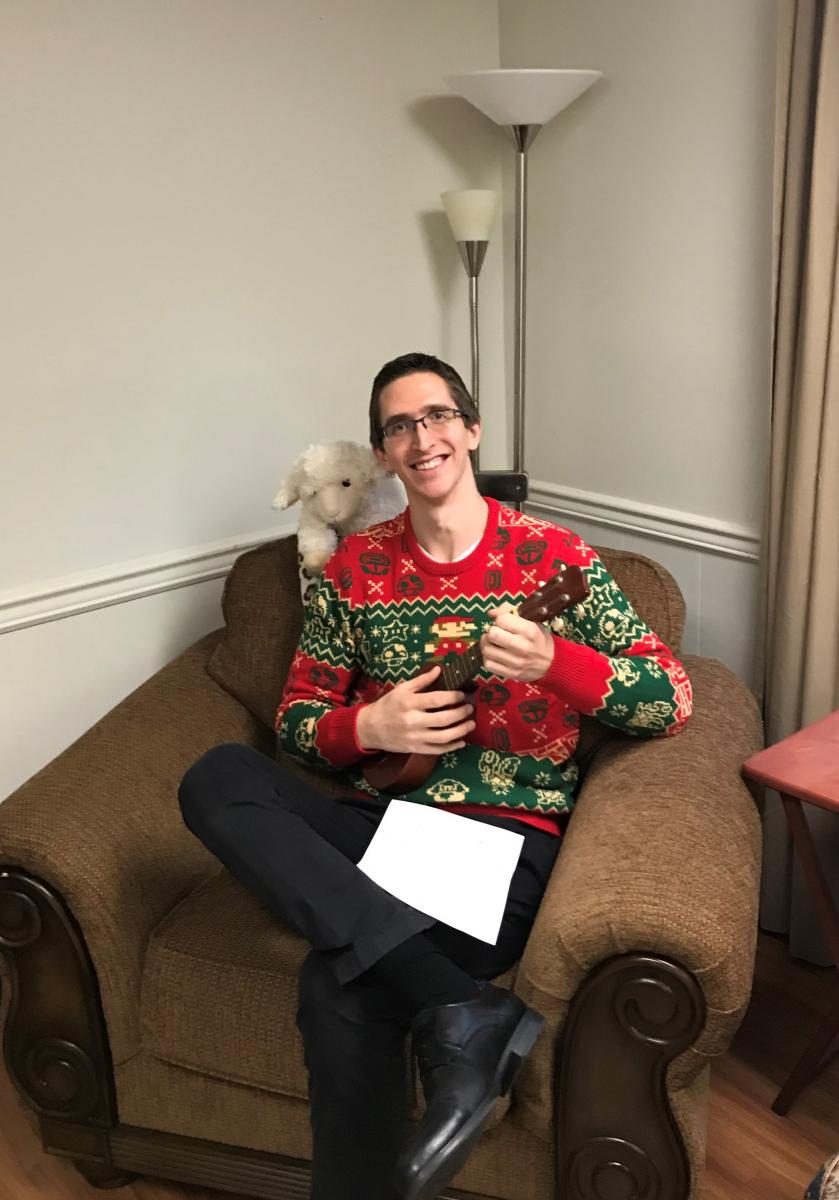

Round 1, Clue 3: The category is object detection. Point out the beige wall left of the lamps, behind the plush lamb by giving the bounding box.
[0,0,504,796]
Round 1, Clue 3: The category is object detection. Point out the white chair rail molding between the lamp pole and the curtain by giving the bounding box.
[527,480,761,563]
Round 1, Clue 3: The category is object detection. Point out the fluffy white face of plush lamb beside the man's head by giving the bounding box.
[274,442,386,527]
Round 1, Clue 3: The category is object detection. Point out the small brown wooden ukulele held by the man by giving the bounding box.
[361,566,588,796]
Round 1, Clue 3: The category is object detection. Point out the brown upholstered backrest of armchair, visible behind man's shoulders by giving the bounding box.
[208,536,684,728]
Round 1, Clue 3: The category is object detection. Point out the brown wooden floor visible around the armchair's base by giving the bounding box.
[0,934,839,1200]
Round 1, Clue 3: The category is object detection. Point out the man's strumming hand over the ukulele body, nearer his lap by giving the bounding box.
[355,667,475,755]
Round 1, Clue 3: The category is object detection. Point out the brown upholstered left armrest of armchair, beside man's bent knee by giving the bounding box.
[0,632,274,1063]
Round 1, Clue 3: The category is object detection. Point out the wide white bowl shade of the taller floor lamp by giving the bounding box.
[445,68,603,125]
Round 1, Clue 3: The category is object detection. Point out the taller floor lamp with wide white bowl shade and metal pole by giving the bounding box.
[445,68,603,508]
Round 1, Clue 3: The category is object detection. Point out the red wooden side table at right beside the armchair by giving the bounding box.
[743,709,839,1115]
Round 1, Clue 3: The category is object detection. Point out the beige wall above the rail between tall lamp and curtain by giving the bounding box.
[499,0,775,530]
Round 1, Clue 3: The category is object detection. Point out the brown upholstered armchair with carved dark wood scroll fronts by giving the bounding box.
[0,539,761,1200]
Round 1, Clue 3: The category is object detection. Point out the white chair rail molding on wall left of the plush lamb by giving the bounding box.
[0,521,295,634]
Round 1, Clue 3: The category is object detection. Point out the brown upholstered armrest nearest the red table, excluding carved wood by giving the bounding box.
[516,656,762,1104]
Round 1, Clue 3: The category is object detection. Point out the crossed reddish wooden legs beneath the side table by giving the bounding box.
[772,793,839,1116]
